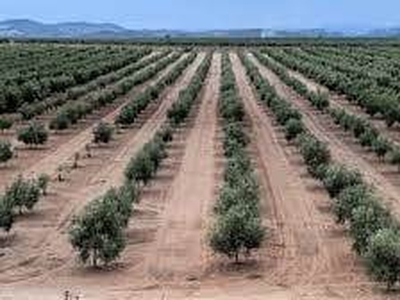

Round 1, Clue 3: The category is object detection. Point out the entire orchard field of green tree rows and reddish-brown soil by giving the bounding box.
[0,41,400,300]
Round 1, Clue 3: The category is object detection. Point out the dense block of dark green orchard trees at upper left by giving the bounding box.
[0,44,154,120]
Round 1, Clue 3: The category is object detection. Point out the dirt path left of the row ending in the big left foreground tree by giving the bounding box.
[0,53,205,289]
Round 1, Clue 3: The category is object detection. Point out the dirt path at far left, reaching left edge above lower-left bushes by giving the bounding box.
[0,51,181,190]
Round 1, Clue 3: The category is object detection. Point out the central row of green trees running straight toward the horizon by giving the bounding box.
[209,53,265,262]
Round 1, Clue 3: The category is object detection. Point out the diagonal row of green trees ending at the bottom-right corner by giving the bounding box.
[241,55,400,288]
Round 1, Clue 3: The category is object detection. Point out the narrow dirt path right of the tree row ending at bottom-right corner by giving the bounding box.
[249,55,400,216]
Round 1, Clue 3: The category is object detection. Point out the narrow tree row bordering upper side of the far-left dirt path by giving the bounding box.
[50,53,181,130]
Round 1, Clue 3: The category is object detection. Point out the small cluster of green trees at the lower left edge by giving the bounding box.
[0,174,50,232]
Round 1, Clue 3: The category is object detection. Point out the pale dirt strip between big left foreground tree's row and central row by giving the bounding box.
[144,54,221,281]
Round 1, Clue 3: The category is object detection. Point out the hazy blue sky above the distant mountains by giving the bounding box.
[0,0,400,29]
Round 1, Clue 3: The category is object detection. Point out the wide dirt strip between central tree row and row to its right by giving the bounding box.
[231,54,360,286]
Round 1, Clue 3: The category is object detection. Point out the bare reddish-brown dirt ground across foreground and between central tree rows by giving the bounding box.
[0,52,399,300]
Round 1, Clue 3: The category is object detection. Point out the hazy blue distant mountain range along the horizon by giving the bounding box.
[0,19,400,39]
